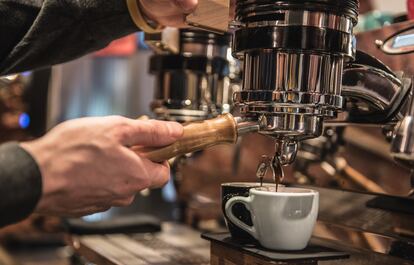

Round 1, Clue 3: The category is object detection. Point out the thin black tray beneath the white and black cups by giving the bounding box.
[201,232,350,264]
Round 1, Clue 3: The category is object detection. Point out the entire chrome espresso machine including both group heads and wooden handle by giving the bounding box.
[65,0,414,265]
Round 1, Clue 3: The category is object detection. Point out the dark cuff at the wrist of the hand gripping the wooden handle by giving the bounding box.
[0,143,42,227]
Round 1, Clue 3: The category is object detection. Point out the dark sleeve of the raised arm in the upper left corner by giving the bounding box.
[0,0,138,75]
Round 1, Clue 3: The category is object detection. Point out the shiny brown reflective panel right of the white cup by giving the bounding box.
[314,185,414,264]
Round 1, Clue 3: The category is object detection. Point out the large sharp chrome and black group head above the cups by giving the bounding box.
[233,0,357,158]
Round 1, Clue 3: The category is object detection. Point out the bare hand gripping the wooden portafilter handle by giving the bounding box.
[21,116,183,216]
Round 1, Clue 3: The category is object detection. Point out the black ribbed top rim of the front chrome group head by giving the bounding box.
[236,0,359,25]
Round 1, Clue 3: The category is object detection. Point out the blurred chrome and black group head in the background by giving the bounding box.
[146,28,239,122]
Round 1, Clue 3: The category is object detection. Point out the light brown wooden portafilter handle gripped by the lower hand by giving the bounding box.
[133,114,259,163]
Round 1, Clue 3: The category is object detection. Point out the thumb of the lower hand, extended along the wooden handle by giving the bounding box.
[121,120,184,147]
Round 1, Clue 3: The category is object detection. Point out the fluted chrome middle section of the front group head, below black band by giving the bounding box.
[235,50,344,111]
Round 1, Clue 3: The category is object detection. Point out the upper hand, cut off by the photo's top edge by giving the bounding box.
[137,0,198,27]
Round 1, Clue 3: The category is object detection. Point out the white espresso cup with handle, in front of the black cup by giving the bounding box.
[225,187,319,250]
